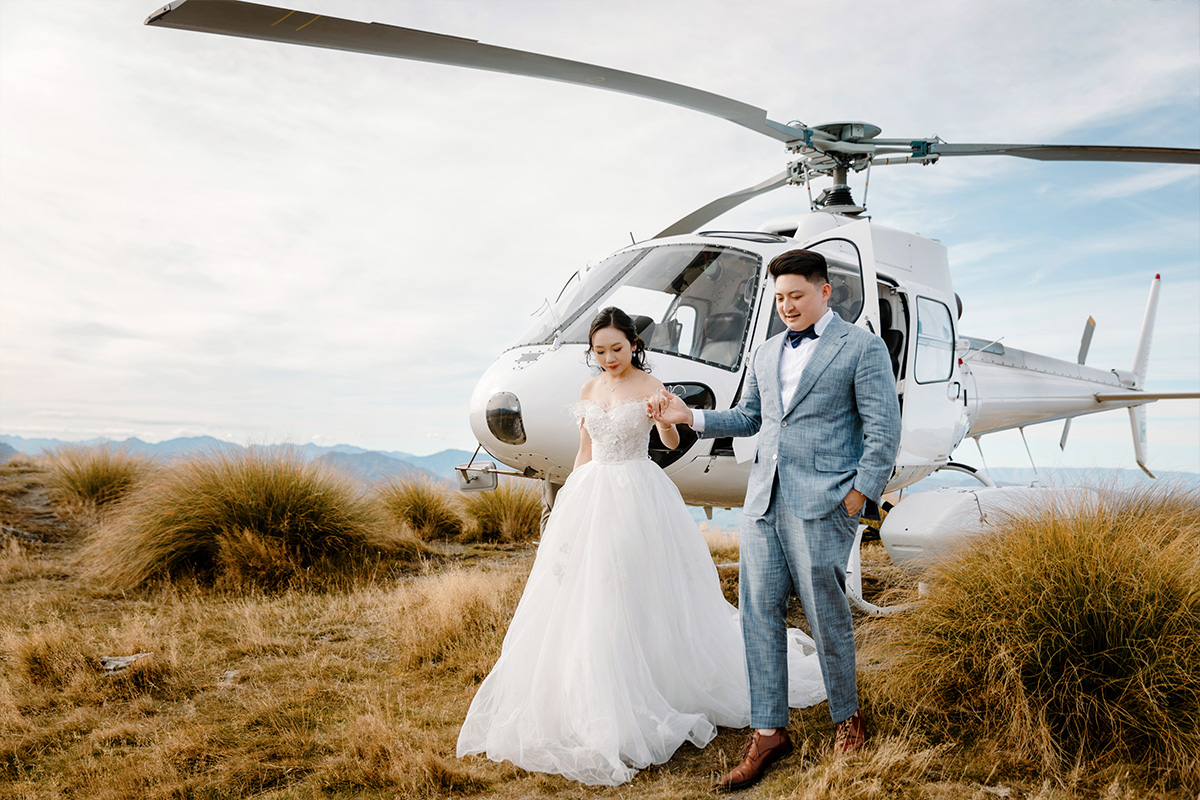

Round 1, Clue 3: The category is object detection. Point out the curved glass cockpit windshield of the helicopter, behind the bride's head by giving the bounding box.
[522,245,762,369]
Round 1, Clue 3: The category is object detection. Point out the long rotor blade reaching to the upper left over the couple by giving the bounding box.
[145,0,805,142]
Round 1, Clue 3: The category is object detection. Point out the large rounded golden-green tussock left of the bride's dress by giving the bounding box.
[83,449,425,589]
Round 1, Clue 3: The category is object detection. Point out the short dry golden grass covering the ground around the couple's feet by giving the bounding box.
[0,462,1190,800]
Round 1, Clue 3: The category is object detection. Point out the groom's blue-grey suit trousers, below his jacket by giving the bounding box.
[738,483,858,728]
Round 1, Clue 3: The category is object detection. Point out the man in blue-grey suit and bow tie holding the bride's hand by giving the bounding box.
[650,249,900,789]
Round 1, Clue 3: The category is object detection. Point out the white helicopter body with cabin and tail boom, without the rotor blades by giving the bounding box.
[470,212,1171,507]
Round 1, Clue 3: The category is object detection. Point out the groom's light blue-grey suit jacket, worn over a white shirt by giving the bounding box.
[703,314,900,519]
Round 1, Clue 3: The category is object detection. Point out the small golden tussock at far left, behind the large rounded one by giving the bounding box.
[46,445,156,509]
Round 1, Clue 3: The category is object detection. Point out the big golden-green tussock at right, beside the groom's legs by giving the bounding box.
[872,487,1200,786]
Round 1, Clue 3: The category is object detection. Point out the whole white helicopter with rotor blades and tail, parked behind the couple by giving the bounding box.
[146,0,1200,606]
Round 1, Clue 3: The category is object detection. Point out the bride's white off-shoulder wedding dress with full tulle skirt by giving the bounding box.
[457,401,826,786]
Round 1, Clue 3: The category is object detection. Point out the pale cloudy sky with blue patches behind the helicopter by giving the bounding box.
[0,0,1200,473]
